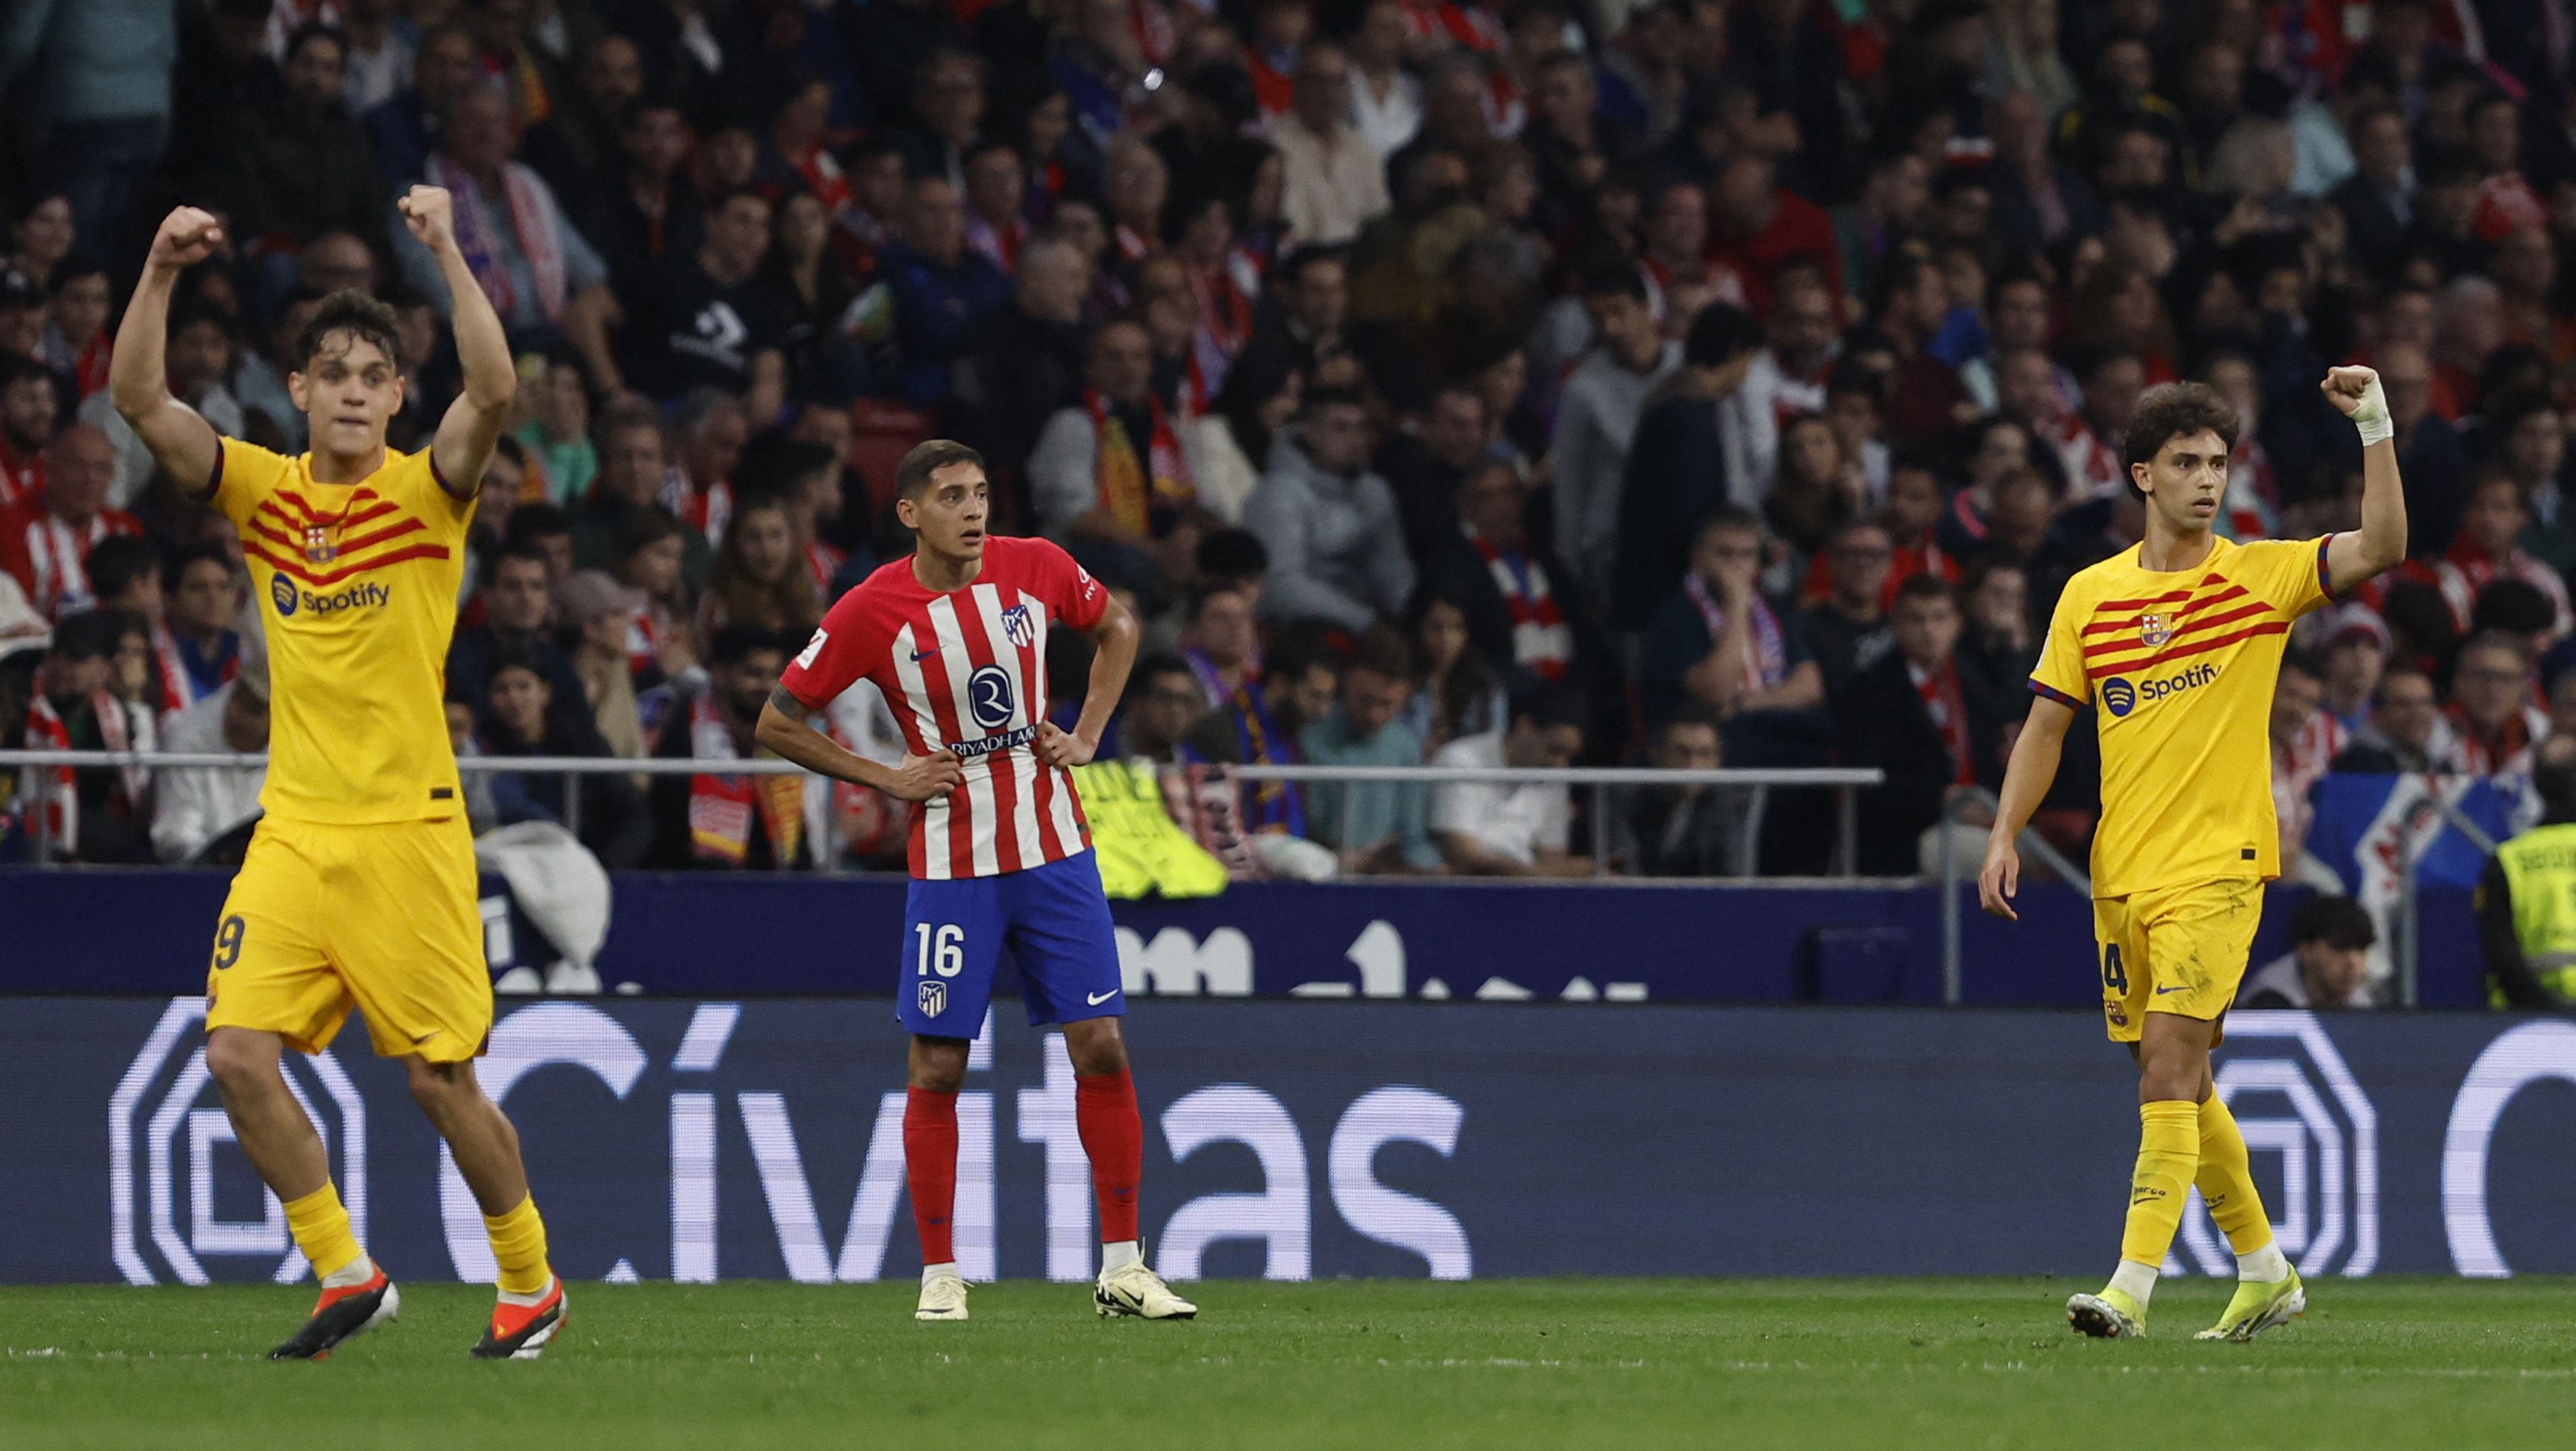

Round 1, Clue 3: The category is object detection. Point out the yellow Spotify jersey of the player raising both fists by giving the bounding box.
[214,438,474,825]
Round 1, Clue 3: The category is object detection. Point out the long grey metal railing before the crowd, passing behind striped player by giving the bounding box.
[0,750,1885,876]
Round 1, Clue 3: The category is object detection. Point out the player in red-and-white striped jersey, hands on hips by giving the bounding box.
[758,438,1198,1320]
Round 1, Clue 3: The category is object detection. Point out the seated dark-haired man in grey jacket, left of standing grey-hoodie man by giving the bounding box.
[1245,389,1414,631]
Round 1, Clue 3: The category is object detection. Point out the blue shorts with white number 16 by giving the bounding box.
[894,850,1125,1039]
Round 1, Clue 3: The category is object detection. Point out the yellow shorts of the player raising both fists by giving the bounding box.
[206,817,492,1062]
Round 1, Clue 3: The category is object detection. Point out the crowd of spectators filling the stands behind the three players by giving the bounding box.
[0,0,2576,887]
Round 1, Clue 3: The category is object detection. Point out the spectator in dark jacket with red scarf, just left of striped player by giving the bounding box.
[652,624,816,871]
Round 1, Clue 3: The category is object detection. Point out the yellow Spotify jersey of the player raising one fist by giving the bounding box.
[2030,539,2329,897]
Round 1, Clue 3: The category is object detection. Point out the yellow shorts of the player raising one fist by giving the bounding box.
[2095,876,2262,1044]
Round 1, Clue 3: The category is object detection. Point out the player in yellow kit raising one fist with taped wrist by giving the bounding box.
[1975,369,2406,1340]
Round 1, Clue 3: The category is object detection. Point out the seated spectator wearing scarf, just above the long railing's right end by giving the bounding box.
[1644,505,1824,721]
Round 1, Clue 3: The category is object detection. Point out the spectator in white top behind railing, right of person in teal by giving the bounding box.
[1430,688,1600,876]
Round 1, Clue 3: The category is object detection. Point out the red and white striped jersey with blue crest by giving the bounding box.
[778,539,1110,882]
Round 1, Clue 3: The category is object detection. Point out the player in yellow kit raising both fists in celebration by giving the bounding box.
[108,185,564,1361]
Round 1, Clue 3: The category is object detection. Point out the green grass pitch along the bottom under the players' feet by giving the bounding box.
[0,1279,2576,1451]
